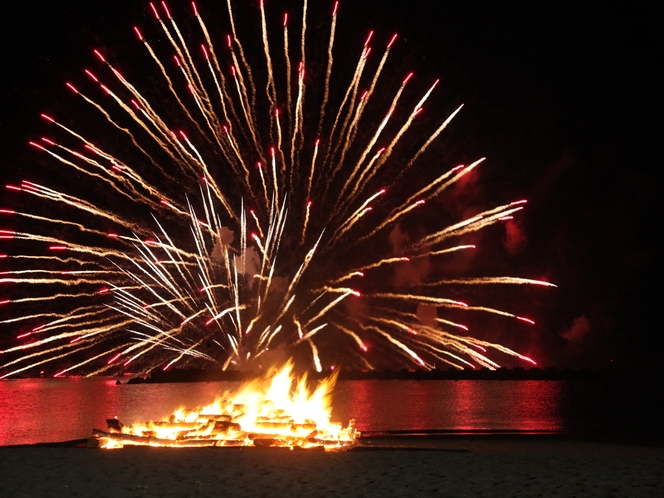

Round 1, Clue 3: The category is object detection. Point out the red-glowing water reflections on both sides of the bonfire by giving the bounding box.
[0,378,570,445]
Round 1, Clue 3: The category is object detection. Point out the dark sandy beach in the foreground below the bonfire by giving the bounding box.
[0,438,664,498]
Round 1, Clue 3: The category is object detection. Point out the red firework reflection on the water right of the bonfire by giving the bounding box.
[333,380,564,431]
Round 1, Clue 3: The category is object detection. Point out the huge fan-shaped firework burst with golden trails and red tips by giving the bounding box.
[0,0,552,378]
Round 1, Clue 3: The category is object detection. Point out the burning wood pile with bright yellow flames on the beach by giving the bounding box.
[93,362,358,449]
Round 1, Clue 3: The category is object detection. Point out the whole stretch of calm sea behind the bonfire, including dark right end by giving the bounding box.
[0,378,664,445]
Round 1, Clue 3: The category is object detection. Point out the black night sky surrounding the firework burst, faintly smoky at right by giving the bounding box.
[0,0,664,367]
